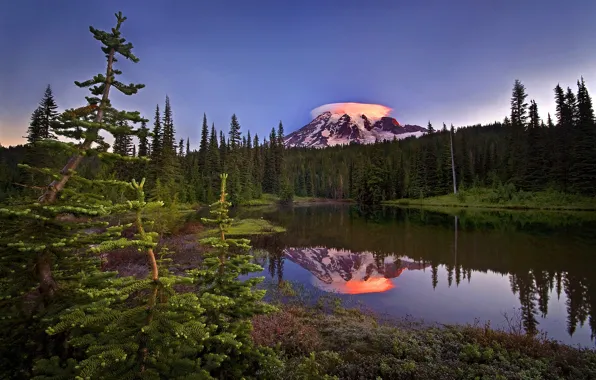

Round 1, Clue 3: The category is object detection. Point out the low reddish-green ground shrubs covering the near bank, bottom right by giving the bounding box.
[252,282,596,380]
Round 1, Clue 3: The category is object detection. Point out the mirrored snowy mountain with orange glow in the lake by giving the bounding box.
[283,247,429,294]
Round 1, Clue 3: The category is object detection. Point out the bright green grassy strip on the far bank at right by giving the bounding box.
[383,186,596,211]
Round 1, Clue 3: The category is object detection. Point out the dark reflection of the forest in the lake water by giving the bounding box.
[246,206,596,338]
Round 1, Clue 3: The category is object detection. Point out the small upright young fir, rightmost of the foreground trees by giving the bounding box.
[192,174,275,379]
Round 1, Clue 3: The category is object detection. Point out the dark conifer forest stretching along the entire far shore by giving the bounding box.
[0,61,596,204]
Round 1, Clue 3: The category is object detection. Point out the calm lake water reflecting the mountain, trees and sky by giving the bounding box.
[240,205,596,347]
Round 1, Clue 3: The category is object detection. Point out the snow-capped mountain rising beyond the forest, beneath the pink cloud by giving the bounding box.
[284,110,426,148]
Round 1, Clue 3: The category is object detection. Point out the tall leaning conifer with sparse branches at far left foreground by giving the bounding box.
[0,13,150,378]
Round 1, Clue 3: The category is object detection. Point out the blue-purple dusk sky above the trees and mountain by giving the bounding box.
[0,0,596,148]
